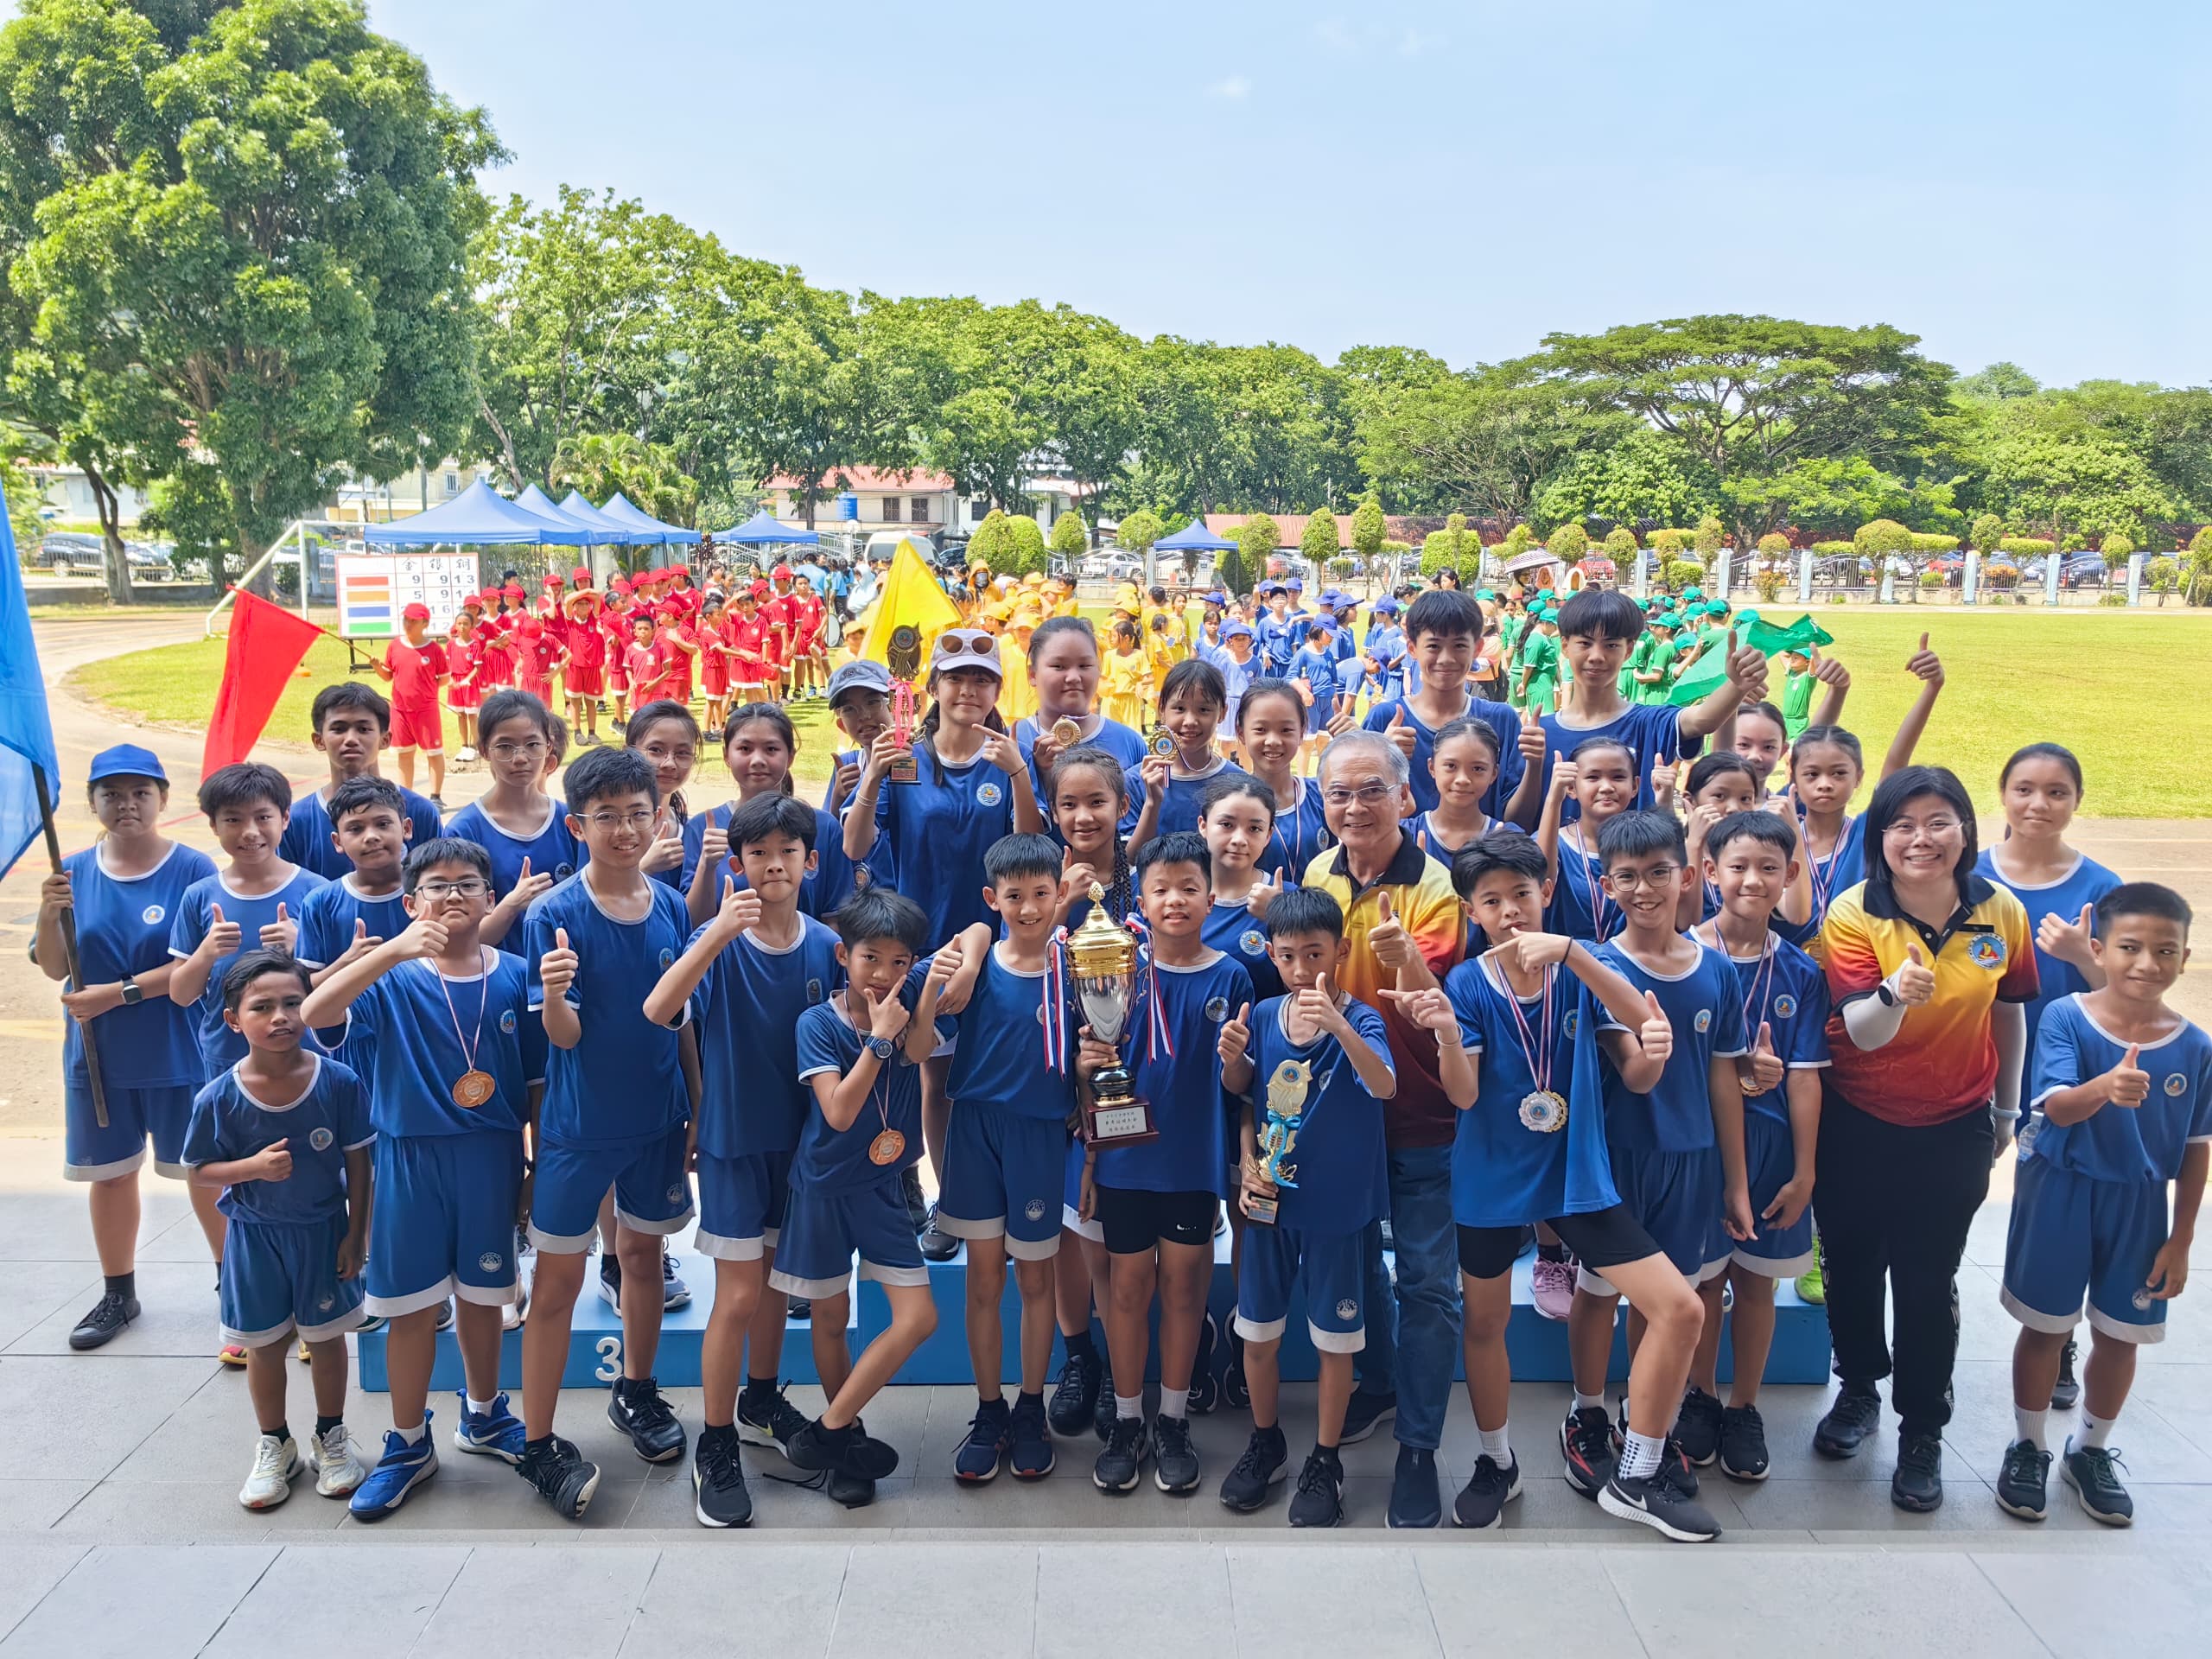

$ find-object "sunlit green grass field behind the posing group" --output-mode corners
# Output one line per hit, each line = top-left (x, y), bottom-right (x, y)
(71, 606), (2212, 818)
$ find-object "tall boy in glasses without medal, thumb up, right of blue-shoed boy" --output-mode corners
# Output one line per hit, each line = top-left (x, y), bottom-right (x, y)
(522, 750), (696, 1520)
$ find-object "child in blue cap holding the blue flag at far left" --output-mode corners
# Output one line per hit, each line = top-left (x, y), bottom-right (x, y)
(33, 743), (224, 1350)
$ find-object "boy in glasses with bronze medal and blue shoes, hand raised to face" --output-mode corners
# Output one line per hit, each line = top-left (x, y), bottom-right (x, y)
(303, 838), (546, 1522)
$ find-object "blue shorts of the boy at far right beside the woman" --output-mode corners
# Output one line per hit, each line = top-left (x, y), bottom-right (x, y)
(1999, 1157), (2168, 1343)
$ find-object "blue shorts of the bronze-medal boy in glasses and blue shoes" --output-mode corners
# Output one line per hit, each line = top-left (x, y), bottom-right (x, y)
(367, 1128), (522, 1319)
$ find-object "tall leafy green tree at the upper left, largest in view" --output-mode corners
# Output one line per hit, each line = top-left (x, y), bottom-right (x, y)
(0, 0), (500, 584)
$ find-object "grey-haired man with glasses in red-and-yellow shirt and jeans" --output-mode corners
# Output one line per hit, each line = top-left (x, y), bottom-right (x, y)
(1300, 732), (1466, 1526)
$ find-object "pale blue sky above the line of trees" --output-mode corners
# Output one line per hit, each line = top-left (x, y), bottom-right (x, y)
(26, 0), (2212, 385)
